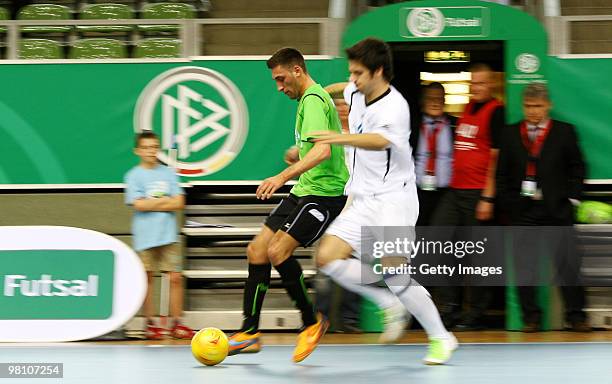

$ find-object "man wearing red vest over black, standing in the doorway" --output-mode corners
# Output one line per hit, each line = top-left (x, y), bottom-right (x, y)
(432, 64), (505, 330)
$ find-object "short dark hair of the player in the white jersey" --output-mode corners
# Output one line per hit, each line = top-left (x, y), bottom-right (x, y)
(346, 37), (393, 81)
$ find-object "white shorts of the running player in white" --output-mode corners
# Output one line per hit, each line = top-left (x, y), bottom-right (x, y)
(325, 191), (419, 258)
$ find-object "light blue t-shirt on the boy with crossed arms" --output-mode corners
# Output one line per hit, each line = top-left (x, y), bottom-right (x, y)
(125, 164), (183, 251)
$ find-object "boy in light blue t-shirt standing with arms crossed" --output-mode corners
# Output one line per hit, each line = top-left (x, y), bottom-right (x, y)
(125, 131), (193, 339)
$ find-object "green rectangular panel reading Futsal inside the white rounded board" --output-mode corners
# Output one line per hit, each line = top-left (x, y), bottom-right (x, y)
(0, 249), (115, 320)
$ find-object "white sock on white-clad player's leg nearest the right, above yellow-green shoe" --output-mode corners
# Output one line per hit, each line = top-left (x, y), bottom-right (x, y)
(385, 278), (449, 339)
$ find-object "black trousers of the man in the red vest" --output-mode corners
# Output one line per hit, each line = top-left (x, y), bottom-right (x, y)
(431, 188), (492, 323)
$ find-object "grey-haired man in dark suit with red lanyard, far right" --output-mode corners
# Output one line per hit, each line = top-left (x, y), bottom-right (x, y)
(496, 83), (590, 332)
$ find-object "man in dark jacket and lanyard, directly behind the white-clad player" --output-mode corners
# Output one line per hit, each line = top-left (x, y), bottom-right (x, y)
(410, 82), (457, 226)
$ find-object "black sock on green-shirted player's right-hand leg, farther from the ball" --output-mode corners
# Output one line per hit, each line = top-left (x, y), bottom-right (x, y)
(274, 257), (317, 327)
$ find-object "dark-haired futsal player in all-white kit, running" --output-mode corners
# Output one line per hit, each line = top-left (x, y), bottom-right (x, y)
(316, 38), (457, 365)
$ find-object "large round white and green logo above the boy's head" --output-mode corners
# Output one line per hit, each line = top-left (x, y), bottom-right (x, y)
(134, 66), (249, 177)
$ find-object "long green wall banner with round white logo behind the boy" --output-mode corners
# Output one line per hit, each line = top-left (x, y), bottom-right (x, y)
(0, 58), (346, 184)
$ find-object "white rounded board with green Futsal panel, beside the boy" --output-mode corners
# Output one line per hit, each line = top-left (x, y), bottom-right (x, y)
(0, 226), (146, 342)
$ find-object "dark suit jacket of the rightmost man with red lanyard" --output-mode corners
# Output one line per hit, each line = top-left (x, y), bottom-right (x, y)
(497, 120), (585, 225)
